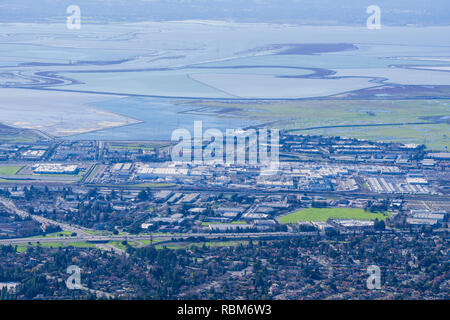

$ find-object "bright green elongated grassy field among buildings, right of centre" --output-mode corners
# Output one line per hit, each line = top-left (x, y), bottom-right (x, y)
(279, 208), (390, 224)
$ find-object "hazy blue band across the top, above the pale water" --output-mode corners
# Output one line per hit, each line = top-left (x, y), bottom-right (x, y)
(0, 0), (450, 25)
